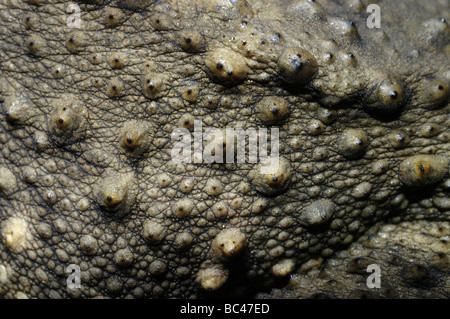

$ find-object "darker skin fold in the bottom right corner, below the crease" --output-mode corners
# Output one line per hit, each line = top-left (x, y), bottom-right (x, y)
(258, 220), (450, 299)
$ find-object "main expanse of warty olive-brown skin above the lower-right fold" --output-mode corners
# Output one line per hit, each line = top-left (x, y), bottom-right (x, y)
(0, 0), (450, 298)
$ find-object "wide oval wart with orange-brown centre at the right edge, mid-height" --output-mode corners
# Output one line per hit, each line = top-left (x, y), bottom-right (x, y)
(399, 155), (449, 187)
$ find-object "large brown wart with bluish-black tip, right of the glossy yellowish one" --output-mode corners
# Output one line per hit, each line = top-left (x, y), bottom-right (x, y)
(278, 48), (318, 84)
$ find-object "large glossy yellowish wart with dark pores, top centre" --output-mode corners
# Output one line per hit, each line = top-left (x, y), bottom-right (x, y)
(205, 48), (249, 86)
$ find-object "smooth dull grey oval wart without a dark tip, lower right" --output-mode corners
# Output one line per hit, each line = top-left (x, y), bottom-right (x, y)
(298, 199), (336, 226)
